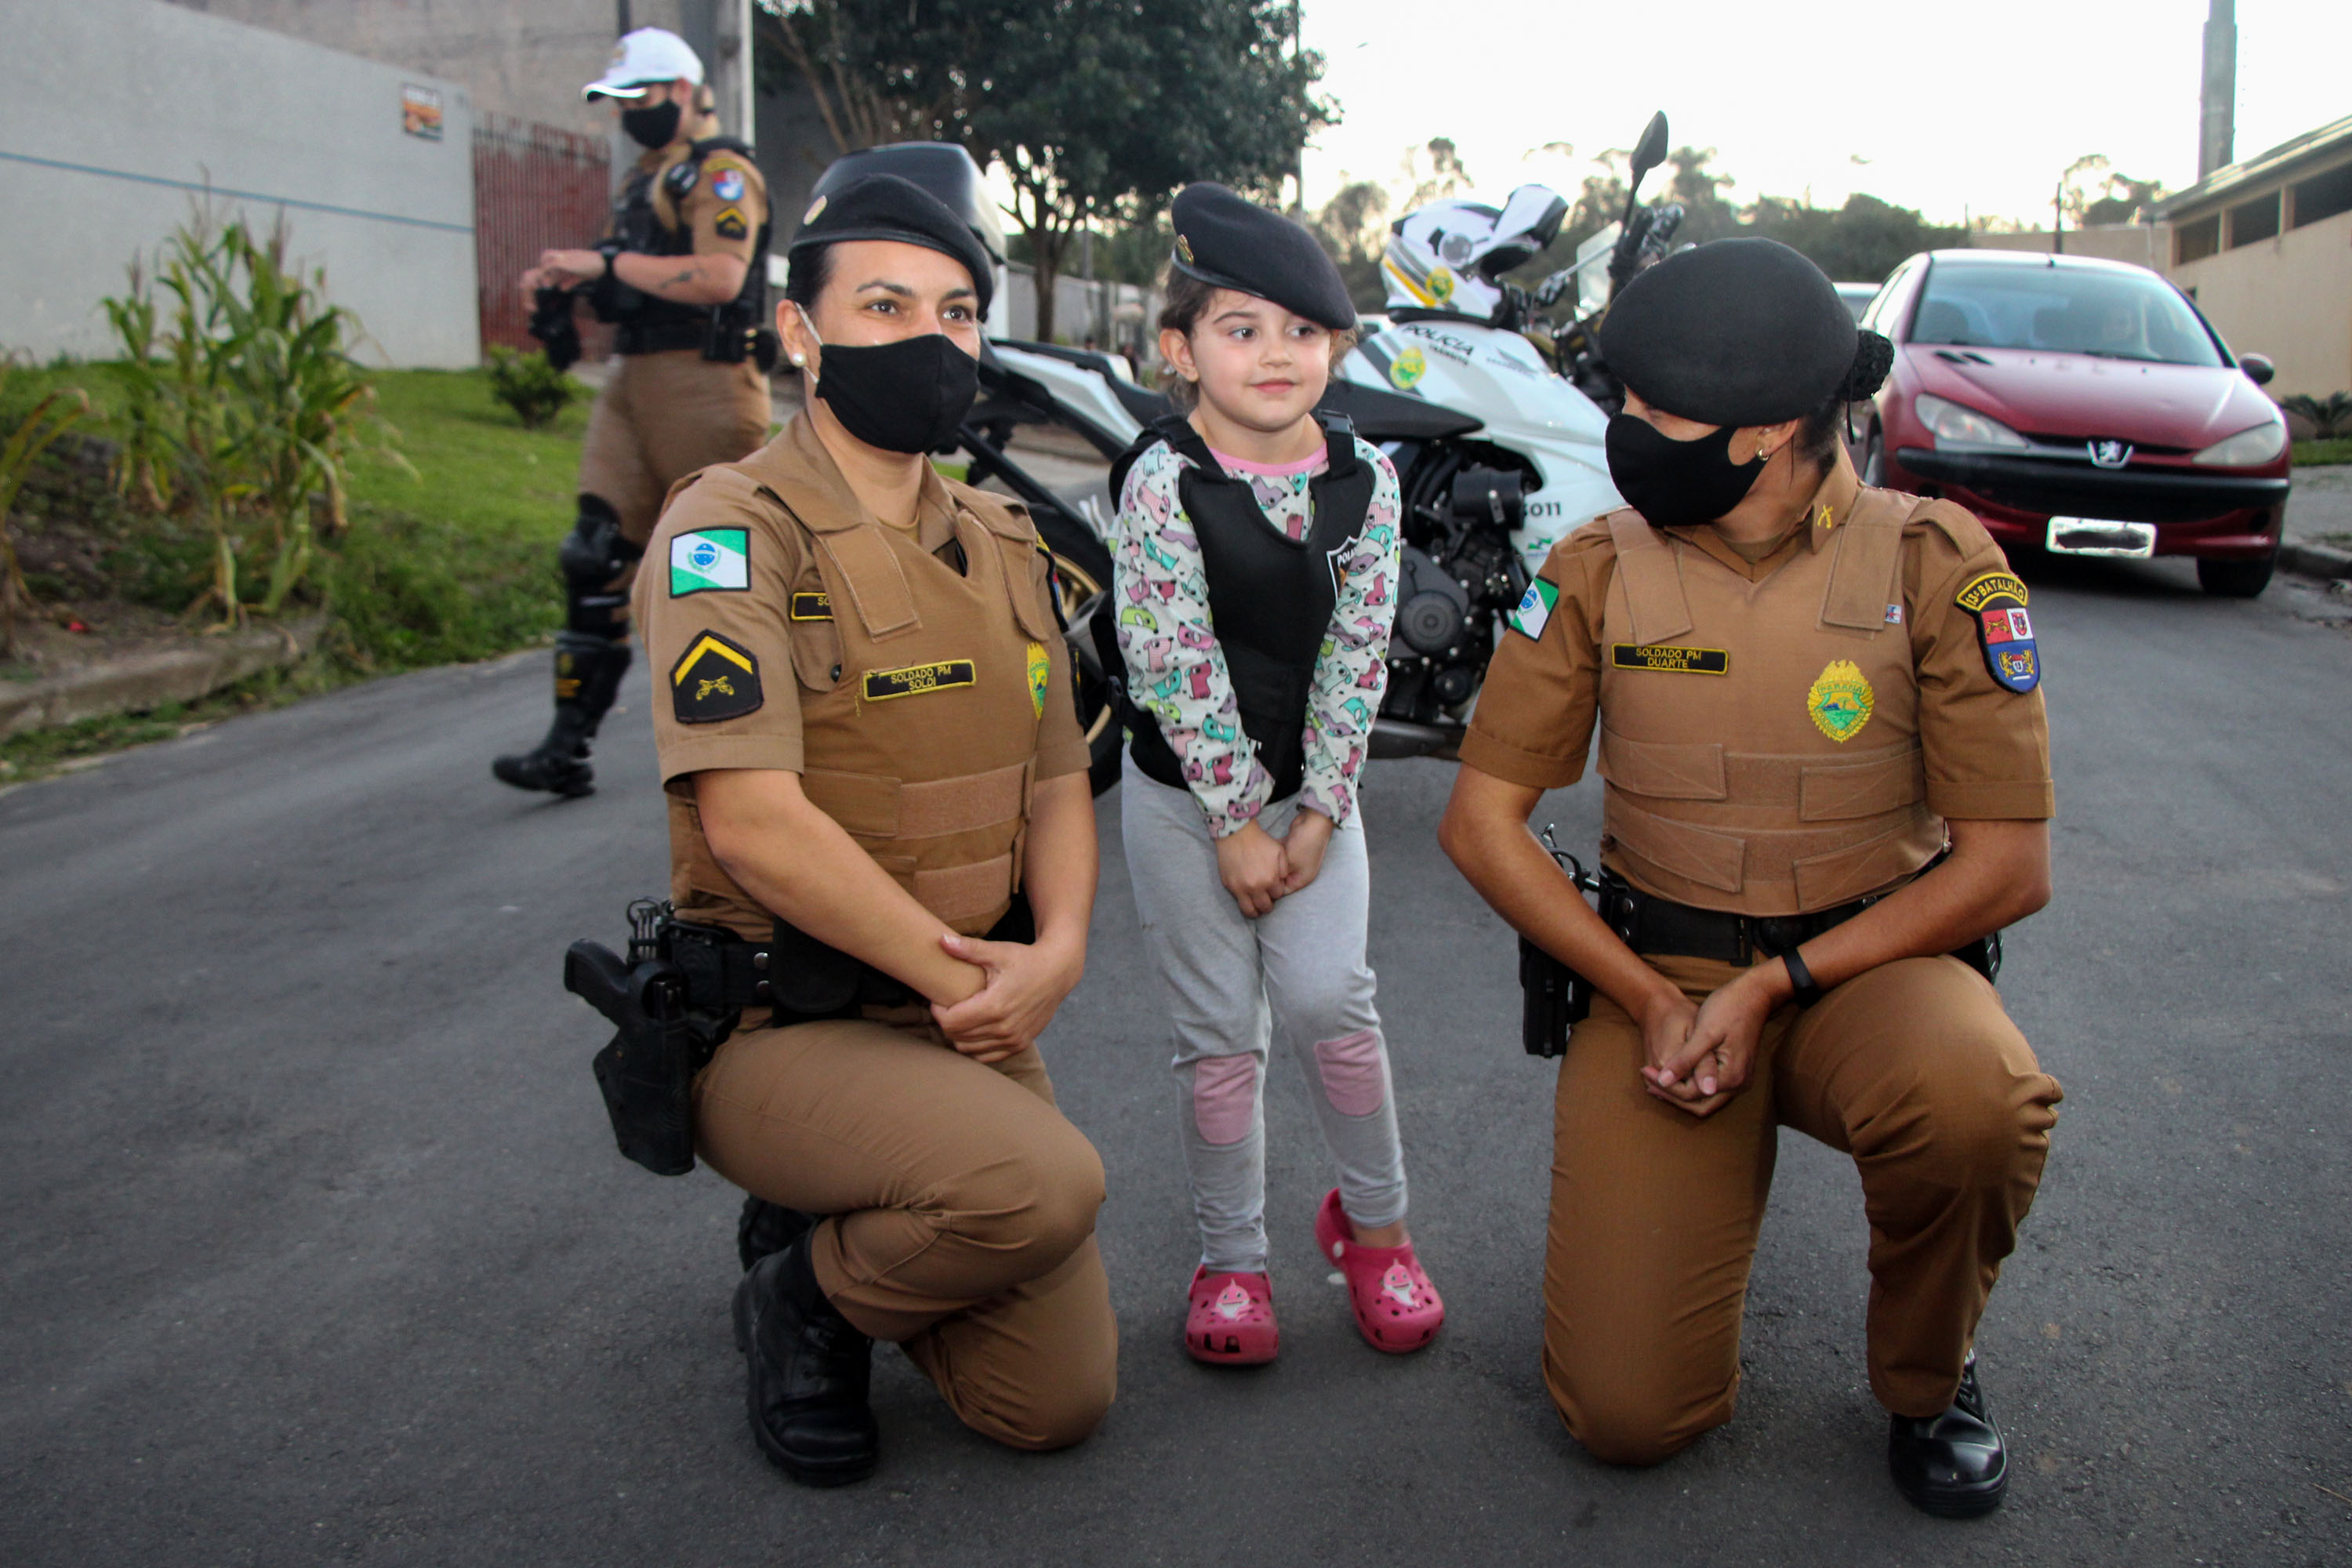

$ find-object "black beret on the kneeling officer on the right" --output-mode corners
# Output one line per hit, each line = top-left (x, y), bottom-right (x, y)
(1602, 240), (1884, 426)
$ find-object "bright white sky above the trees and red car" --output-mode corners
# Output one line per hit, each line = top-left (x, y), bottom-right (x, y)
(1303, 0), (2352, 226)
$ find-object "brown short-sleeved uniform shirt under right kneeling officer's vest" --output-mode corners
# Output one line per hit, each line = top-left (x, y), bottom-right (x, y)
(1461, 454), (2056, 846)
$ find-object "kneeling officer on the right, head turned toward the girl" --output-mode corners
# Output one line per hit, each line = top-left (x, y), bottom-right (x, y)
(1442, 240), (2058, 1516)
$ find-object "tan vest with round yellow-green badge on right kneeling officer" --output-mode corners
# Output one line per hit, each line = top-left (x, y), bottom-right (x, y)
(1599, 489), (1959, 914)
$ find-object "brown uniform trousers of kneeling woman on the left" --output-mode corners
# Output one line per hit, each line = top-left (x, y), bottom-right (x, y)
(694, 1020), (1120, 1448)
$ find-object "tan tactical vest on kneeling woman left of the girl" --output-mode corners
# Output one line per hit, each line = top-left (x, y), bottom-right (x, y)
(670, 430), (1061, 940)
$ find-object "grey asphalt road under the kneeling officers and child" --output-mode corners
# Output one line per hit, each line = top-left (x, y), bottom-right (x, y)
(0, 564), (2352, 1568)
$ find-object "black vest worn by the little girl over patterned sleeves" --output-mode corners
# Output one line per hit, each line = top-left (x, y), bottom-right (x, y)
(1096, 412), (1374, 799)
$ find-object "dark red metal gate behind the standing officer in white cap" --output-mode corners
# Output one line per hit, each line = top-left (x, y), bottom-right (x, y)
(473, 115), (612, 358)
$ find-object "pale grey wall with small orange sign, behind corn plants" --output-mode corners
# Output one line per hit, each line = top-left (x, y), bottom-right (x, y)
(0, 0), (480, 365)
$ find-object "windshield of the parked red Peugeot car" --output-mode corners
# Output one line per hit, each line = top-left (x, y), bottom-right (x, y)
(1910, 261), (2223, 365)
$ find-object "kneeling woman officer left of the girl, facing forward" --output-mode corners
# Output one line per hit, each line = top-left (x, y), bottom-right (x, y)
(637, 174), (1117, 1486)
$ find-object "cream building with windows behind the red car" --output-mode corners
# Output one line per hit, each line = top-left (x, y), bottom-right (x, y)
(2154, 115), (2352, 397)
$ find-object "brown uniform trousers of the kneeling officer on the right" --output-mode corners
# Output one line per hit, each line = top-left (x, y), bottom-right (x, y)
(1543, 956), (2060, 1465)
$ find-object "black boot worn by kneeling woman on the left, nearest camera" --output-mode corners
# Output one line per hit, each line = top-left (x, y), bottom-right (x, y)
(734, 1232), (882, 1486)
